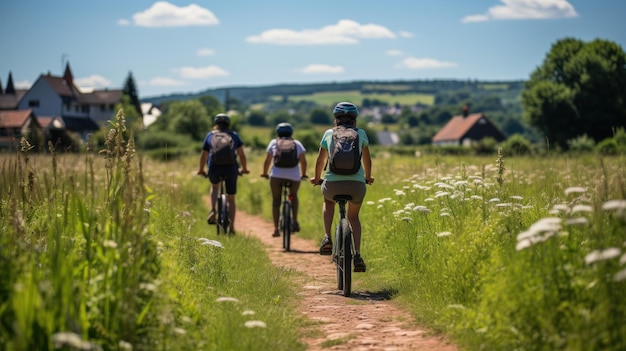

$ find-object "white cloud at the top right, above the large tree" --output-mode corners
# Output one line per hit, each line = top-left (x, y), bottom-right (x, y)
(461, 0), (578, 23)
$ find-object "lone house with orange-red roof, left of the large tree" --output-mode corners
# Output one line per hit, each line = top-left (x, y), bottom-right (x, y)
(432, 106), (506, 146)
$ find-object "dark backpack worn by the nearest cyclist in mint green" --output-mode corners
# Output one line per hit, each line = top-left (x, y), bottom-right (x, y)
(328, 125), (361, 175)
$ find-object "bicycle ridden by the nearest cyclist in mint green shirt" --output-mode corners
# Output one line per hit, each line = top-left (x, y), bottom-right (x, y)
(332, 195), (355, 297)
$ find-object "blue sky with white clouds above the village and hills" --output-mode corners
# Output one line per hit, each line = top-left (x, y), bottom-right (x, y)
(0, 0), (626, 97)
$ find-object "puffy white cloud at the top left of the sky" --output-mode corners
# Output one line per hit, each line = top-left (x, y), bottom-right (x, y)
(130, 1), (219, 27)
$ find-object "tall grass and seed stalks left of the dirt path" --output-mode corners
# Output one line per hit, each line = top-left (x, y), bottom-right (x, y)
(0, 112), (302, 350)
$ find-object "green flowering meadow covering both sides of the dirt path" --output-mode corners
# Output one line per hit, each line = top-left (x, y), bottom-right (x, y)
(0, 119), (626, 351)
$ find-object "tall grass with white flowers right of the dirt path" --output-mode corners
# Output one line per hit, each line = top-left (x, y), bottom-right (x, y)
(235, 152), (626, 350)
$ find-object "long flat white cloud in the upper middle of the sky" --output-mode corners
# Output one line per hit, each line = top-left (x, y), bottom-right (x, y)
(246, 19), (396, 45)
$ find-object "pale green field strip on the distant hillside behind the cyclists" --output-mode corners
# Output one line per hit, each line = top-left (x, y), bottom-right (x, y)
(274, 87), (435, 106)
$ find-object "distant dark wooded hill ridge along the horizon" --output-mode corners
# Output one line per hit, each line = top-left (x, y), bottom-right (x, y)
(141, 80), (524, 105)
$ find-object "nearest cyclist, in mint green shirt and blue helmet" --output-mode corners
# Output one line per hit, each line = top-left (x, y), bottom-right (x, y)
(310, 102), (374, 272)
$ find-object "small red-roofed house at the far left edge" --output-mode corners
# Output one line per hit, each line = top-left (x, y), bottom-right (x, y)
(0, 110), (43, 151)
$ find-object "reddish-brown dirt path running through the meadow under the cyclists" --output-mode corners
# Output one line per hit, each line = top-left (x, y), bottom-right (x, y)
(235, 211), (458, 351)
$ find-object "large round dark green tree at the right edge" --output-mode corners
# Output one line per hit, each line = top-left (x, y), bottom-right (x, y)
(522, 38), (626, 148)
